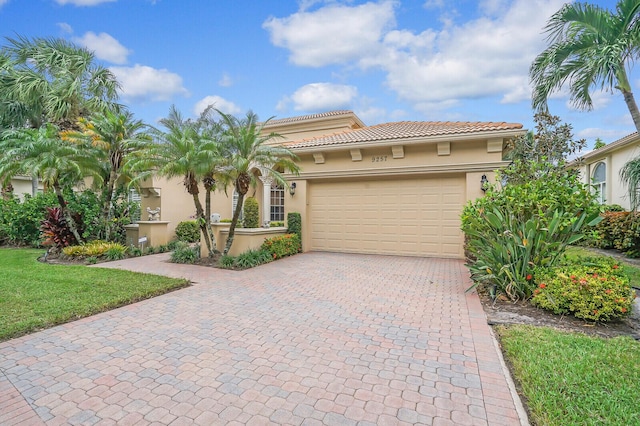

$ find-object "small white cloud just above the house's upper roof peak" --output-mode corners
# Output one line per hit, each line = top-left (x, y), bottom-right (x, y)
(290, 83), (358, 112)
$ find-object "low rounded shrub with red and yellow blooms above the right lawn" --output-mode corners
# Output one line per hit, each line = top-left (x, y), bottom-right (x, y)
(531, 264), (635, 322)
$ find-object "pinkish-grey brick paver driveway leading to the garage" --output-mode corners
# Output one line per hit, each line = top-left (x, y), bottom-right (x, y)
(0, 253), (524, 425)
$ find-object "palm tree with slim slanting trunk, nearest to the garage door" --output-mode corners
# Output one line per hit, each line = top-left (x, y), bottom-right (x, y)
(216, 110), (299, 255)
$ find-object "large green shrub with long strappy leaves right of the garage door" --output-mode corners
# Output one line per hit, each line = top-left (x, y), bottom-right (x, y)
(461, 163), (601, 301)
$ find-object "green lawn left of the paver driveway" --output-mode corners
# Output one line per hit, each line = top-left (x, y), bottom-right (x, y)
(0, 249), (187, 341)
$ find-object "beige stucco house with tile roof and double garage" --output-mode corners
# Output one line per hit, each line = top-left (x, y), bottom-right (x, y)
(141, 111), (525, 258)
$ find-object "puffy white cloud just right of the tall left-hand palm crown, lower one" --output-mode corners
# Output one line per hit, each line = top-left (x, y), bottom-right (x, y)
(110, 64), (189, 102)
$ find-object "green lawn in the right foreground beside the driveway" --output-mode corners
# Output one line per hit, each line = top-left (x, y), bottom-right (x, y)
(496, 326), (640, 426)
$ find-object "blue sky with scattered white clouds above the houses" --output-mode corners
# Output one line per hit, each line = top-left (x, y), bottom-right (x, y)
(0, 0), (640, 145)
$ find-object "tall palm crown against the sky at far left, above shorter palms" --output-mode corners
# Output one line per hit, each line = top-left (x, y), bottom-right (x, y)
(0, 37), (119, 195)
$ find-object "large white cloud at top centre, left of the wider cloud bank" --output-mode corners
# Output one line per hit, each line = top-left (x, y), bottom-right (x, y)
(263, 1), (395, 67)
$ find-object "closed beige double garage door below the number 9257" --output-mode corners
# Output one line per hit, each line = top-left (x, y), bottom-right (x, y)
(309, 176), (465, 258)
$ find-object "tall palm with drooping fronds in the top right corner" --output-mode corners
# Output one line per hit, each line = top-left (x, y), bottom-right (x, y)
(530, 0), (640, 132)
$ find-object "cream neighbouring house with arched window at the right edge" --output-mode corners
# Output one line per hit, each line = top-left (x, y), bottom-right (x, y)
(576, 133), (640, 210)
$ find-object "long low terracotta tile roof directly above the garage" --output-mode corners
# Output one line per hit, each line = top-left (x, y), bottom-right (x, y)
(285, 121), (522, 148)
